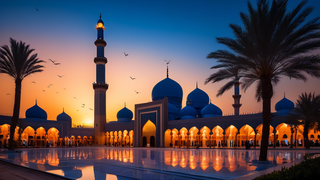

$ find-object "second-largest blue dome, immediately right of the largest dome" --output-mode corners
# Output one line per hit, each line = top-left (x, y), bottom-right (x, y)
(186, 85), (209, 109)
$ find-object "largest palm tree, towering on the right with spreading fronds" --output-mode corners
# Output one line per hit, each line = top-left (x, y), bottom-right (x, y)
(207, 0), (320, 161)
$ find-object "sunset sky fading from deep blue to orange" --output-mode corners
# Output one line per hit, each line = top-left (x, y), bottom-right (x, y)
(0, 0), (320, 125)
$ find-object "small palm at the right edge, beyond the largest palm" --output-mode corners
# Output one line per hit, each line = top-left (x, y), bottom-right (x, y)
(287, 93), (320, 149)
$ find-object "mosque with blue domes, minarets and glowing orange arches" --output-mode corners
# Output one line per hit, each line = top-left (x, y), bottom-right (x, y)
(0, 15), (320, 148)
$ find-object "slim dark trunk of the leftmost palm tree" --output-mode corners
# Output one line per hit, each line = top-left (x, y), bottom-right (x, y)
(9, 79), (22, 150)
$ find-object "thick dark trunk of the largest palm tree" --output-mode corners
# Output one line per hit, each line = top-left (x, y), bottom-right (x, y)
(259, 78), (273, 161)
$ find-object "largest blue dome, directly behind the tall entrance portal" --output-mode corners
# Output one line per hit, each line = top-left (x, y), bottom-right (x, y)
(152, 77), (183, 109)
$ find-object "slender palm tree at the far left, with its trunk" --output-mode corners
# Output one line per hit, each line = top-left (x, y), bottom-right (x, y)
(0, 38), (45, 150)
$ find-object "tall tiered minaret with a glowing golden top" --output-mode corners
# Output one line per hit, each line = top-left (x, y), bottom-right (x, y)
(93, 14), (108, 145)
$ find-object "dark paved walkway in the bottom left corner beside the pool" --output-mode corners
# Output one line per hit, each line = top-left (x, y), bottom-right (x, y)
(0, 160), (69, 180)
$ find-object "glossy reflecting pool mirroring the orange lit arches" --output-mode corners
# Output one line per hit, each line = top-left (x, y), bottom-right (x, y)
(0, 147), (312, 180)
